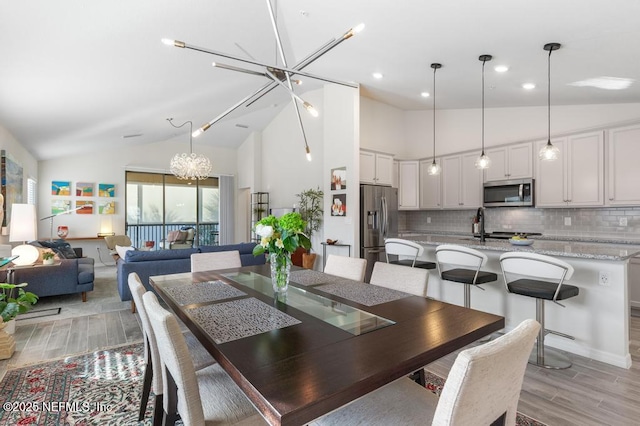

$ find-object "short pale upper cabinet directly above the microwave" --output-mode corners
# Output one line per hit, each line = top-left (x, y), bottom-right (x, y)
(484, 142), (533, 182)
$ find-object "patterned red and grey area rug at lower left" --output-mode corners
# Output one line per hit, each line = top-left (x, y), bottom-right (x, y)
(0, 343), (154, 426)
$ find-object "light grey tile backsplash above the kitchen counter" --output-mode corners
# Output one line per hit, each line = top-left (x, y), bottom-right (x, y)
(398, 207), (640, 240)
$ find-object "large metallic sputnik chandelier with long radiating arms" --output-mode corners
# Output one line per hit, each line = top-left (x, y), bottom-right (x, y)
(162, 0), (364, 161)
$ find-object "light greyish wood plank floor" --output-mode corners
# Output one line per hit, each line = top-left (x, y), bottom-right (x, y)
(0, 271), (640, 426)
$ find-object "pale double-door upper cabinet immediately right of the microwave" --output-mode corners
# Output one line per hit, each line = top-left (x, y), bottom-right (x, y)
(535, 132), (604, 207)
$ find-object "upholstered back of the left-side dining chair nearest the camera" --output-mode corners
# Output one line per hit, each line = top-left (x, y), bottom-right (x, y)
(142, 291), (205, 426)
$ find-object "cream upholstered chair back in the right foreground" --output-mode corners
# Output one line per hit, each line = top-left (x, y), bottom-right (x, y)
(432, 319), (540, 425)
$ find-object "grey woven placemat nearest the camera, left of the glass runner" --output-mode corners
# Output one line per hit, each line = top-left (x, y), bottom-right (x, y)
(187, 297), (301, 343)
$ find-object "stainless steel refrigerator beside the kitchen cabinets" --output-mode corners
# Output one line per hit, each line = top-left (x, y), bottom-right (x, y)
(360, 185), (398, 282)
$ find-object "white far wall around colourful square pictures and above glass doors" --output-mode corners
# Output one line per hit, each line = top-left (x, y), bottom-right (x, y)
(38, 138), (237, 243)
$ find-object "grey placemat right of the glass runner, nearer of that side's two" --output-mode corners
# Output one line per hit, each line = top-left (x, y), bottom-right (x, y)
(315, 279), (411, 306)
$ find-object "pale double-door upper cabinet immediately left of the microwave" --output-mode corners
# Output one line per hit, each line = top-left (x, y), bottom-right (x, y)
(442, 152), (482, 209)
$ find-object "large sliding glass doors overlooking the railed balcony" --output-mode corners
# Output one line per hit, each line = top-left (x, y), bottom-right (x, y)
(126, 172), (220, 248)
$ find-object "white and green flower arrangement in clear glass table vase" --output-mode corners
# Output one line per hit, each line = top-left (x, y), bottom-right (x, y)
(253, 212), (311, 292)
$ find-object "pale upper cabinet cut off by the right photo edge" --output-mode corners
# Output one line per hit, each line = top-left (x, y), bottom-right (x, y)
(606, 126), (640, 206)
